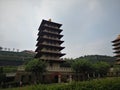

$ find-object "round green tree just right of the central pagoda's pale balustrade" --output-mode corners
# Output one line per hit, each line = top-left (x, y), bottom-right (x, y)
(72, 59), (93, 80)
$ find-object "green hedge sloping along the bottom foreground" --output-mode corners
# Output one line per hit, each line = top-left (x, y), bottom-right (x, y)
(4, 77), (120, 90)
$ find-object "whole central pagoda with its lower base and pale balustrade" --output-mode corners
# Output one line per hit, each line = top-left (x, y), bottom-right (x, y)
(35, 19), (72, 83)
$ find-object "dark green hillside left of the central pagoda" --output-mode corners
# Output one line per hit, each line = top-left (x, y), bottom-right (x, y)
(0, 51), (35, 66)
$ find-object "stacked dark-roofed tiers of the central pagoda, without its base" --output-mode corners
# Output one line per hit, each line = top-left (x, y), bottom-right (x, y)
(35, 20), (65, 62)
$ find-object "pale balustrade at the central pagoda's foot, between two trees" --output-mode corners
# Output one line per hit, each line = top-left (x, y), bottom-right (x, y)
(47, 66), (72, 72)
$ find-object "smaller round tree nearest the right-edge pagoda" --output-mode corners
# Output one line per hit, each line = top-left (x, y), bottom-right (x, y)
(94, 61), (110, 77)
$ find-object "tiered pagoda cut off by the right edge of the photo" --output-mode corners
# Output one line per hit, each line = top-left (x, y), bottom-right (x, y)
(112, 35), (120, 64)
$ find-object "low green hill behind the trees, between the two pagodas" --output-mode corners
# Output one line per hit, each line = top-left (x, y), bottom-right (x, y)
(60, 55), (115, 67)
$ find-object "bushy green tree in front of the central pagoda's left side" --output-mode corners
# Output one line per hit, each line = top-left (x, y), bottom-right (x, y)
(25, 59), (47, 83)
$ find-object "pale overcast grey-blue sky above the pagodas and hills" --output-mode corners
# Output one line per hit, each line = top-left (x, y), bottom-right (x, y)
(0, 0), (120, 58)
